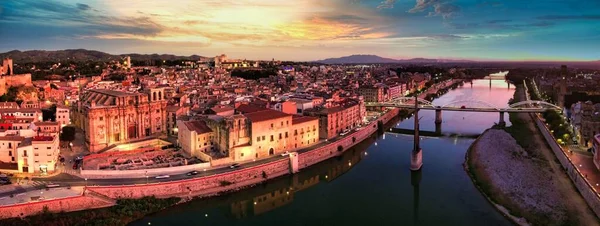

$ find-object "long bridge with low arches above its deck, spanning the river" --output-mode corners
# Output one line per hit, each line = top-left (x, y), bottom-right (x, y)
(365, 97), (561, 113)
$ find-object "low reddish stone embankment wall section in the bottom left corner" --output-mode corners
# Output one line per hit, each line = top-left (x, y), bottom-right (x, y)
(0, 194), (114, 219)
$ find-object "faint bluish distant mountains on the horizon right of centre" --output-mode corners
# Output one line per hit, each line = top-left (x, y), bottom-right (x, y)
(315, 55), (474, 64)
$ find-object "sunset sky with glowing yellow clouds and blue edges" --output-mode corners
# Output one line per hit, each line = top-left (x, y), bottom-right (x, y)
(0, 0), (600, 61)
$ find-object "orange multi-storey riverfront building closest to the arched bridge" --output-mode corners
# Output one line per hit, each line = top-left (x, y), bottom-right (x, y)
(304, 100), (364, 139)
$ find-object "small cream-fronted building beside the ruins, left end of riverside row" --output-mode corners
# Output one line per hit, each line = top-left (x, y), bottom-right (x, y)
(177, 120), (215, 159)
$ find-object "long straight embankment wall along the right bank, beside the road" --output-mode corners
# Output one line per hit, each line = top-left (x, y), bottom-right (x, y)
(530, 113), (600, 217)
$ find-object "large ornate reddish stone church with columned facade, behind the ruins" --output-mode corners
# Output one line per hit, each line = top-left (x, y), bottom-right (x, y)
(74, 88), (167, 152)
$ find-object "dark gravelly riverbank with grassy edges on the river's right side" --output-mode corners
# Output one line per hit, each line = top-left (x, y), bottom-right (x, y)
(465, 84), (600, 225)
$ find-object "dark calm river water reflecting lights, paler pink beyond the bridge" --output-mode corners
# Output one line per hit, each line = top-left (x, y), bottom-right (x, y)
(132, 80), (514, 226)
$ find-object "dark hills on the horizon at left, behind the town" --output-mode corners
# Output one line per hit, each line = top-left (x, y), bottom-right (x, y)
(0, 49), (207, 63)
